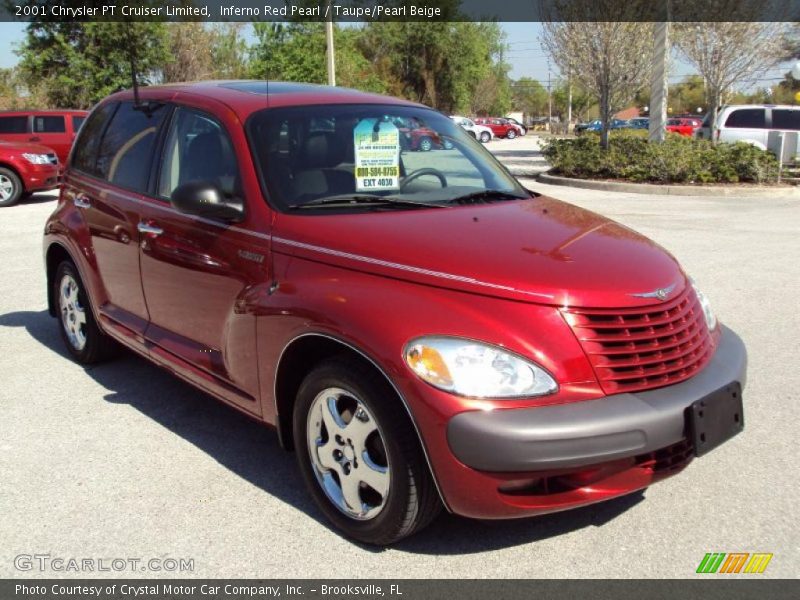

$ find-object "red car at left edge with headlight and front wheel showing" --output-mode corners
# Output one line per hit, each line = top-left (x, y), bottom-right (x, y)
(0, 141), (59, 206)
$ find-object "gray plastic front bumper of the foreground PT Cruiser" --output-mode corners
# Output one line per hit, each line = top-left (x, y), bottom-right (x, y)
(447, 327), (747, 472)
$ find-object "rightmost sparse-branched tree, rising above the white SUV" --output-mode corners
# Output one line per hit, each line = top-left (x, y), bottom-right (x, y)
(675, 21), (785, 135)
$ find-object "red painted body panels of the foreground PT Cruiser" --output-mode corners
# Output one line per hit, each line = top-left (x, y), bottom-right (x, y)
(44, 83), (744, 518)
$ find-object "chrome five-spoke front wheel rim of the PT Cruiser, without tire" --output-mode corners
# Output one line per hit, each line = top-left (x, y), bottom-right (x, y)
(306, 388), (391, 521)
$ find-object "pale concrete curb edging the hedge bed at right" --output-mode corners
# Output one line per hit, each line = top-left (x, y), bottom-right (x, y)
(536, 173), (800, 198)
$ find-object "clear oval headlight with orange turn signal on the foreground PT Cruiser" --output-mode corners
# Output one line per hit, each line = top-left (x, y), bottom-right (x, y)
(404, 337), (558, 398)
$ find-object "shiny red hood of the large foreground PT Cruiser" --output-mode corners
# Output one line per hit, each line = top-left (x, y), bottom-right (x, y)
(273, 196), (686, 308)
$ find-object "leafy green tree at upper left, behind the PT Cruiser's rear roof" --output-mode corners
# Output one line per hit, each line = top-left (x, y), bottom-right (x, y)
(17, 21), (169, 108)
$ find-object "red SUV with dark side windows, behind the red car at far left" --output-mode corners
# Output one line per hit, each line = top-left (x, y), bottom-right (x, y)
(0, 110), (89, 164)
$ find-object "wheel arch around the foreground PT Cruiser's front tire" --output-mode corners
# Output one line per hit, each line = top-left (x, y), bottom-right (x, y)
(273, 332), (450, 511)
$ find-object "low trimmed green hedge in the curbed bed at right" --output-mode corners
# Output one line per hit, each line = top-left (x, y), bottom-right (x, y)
(542, 130), (778, 184)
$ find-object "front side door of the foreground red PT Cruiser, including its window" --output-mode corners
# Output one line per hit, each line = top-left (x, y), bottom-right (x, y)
(140, 106), (262, 414)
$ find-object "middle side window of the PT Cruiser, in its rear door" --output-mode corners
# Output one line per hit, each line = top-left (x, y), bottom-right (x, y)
(96, 102), (167, 192)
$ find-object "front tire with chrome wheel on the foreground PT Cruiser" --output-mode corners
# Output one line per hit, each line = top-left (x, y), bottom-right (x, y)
(293, 357), (441, 545)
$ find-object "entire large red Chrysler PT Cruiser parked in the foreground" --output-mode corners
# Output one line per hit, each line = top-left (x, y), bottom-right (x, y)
(44, 82), (746, 544)
